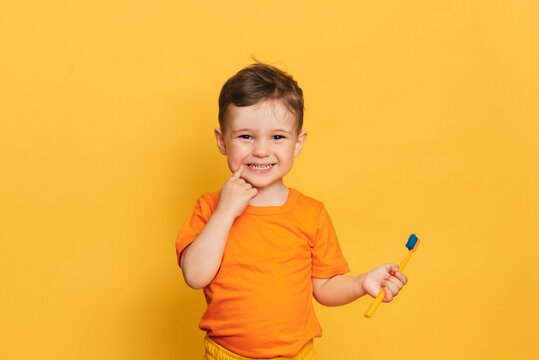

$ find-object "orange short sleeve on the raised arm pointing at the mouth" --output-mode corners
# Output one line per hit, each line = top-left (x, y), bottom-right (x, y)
(176, 195), (215, 265)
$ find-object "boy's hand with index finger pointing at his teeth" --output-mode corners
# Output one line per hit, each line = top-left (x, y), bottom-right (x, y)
(215, 165), (258, 219)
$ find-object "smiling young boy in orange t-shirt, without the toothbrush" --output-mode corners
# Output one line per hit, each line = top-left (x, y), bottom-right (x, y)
(176, 63), (407, 359)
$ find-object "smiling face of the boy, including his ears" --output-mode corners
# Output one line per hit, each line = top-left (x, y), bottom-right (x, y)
(215, 101), (307, 190)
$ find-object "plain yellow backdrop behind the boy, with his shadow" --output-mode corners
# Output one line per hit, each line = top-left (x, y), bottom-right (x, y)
(0, 0), (539, 359)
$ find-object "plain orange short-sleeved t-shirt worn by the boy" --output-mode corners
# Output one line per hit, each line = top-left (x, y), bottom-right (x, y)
(176, 189), (350, 358)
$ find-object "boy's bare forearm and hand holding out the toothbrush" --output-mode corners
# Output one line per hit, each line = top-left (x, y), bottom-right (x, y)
(312, 264), (408, 306)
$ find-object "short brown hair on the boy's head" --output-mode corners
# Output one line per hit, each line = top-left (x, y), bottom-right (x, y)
(219, 62), (304, 134)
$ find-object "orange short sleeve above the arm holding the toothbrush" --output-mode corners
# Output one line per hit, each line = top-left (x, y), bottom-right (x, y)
(311, 205), (350, 278)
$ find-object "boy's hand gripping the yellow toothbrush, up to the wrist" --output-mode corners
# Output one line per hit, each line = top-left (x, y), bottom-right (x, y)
(361, 264), (408, 302)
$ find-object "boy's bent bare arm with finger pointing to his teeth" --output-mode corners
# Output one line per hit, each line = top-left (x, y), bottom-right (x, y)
(180, 166), (257, 289)
